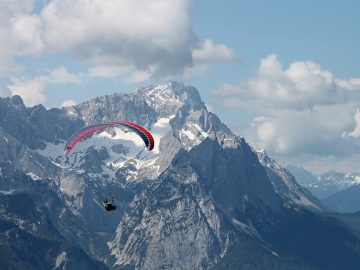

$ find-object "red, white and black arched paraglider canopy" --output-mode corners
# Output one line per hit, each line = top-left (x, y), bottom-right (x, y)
(65, 120), (154, 155)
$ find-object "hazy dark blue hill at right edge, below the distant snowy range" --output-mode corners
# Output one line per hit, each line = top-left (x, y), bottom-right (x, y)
(323, 185), (360, 213)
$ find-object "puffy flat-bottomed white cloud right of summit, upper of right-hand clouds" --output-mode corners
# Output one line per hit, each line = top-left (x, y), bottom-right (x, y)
(213, 54), (360, 110)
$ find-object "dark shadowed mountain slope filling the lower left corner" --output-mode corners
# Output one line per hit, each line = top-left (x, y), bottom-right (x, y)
(0, 162), (107, 270)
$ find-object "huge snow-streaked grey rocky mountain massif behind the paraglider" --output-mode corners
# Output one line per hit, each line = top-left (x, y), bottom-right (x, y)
(0, 82), (360, 269)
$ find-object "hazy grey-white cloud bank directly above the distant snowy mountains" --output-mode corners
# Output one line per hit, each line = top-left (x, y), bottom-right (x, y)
(244, 104), (360, 173)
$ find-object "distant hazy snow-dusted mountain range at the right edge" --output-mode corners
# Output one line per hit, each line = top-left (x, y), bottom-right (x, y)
(287, 166), (360, 200)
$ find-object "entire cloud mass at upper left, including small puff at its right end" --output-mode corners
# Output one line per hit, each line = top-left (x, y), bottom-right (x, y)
(0, 0), (234, 81)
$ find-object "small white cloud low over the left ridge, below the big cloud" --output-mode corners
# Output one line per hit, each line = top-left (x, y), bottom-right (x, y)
(8, 67), (82, 106)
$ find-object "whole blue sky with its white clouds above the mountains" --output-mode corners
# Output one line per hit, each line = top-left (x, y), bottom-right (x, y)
(0, 0), (360, 173)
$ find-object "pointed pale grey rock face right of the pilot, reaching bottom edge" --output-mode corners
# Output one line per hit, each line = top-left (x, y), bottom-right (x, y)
(112, 152), (228, 269)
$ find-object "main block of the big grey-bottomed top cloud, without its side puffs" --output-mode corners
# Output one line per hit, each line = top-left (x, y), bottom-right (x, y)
(41, 0), (196, 75)
